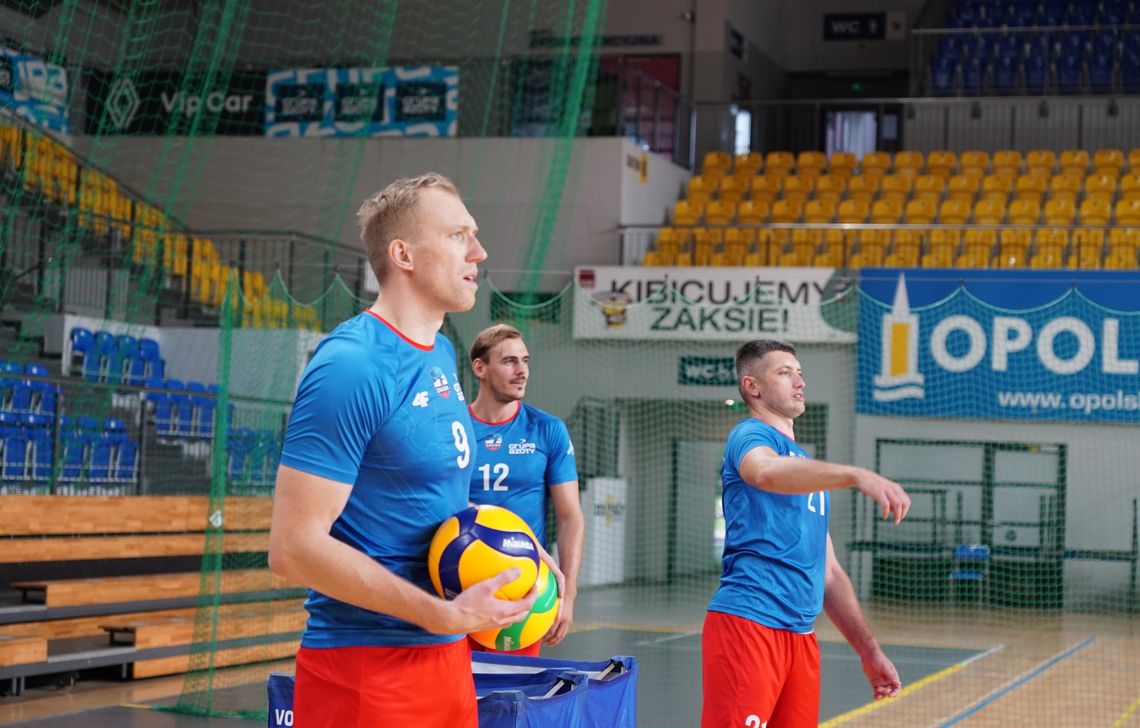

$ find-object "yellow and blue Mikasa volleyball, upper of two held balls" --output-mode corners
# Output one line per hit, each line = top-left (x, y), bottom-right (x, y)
(428, 505), (545, 599)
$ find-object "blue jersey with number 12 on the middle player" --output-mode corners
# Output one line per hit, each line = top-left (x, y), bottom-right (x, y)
(471, 402), (578, 548)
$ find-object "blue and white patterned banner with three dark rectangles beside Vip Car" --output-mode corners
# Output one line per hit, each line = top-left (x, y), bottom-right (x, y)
(266, 66), (459, 137)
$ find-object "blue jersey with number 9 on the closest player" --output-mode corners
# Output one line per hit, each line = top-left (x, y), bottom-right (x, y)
(280, 311), (474, 647)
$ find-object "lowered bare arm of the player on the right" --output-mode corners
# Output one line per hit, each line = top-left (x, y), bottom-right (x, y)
(823, 533), (903, 701)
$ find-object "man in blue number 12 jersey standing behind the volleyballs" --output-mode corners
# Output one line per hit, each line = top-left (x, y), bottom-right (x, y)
(470, 324), (585, 655)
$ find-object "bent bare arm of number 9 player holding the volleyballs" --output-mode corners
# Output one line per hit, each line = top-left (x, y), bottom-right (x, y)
(269, 465), (536, 635)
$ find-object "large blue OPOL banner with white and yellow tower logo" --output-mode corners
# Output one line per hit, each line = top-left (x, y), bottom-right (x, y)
(856, 269), (1140, 423)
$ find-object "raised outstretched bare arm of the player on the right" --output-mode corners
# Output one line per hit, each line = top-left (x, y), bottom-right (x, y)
(740, 445), (911, 523)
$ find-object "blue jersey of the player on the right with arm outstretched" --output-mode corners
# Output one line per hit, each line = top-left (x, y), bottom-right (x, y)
(709, 418), (831, 633)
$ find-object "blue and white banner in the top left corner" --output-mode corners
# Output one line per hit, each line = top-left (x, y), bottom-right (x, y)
(0, 46), (71, 134)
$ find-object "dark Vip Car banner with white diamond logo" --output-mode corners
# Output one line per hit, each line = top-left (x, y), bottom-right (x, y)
(86, 71), (266, 136)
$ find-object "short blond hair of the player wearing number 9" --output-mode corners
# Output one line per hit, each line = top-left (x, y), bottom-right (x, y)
(357, 172), (459, 283)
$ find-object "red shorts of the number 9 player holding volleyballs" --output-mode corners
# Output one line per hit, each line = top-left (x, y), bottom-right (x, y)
(293, 639), (479, 728)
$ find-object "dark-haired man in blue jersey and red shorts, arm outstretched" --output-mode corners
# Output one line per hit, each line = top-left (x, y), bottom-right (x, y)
(701, 340), (911, 728)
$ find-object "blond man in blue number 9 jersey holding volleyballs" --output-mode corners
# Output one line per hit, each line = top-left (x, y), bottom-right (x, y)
(269, 174), (544, 728)
